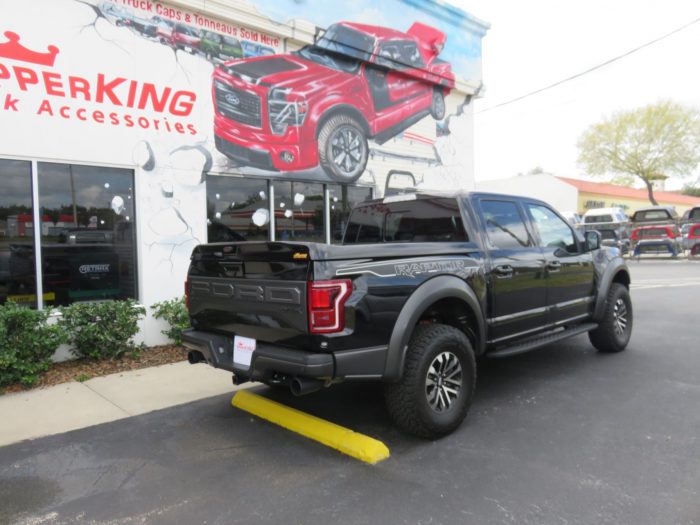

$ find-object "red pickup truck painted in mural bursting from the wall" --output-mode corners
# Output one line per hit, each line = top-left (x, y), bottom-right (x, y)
(212, 22), (454, 183)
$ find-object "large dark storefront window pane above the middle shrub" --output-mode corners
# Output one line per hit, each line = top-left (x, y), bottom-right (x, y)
(38, 162), (136, 306)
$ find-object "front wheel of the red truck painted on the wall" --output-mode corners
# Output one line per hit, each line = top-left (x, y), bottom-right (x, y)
(318, 115), (369, 183)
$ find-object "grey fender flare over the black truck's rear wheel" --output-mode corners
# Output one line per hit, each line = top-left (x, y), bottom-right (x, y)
(384, 275), (486, 381)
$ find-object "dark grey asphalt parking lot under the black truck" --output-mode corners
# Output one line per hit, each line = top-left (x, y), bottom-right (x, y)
(0, 260), (700, 525)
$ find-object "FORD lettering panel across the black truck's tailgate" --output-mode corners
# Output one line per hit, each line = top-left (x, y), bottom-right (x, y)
(190, 279), (303, 305)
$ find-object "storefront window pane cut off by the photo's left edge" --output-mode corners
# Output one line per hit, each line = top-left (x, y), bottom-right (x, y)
(0, 159), (36, 306)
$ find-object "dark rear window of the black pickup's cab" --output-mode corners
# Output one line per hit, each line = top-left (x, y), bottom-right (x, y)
(343, 198), (469, 244)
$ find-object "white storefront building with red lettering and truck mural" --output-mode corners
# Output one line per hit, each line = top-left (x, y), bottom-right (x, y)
(0, 0), (488, 344)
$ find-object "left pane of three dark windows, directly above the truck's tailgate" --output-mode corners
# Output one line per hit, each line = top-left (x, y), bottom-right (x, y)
(207, 175), (270, 242)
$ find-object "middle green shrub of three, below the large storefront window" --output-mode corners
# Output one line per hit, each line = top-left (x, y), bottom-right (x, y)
(59, 299), (146, 359)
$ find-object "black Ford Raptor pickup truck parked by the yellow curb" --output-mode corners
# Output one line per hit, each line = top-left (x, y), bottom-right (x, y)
(183, 193), (632, 438)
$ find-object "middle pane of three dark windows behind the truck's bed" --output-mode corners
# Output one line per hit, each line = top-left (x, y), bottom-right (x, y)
(274, 181), (326, 242)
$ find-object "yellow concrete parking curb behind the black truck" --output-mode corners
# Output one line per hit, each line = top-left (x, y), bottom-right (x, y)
(231, 390), (389, 465)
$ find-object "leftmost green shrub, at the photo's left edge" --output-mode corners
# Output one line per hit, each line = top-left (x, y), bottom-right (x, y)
(0, 301), (67, 386)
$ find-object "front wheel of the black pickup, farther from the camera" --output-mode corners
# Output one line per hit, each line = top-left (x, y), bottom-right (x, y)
(588, 283), (633, 353)
